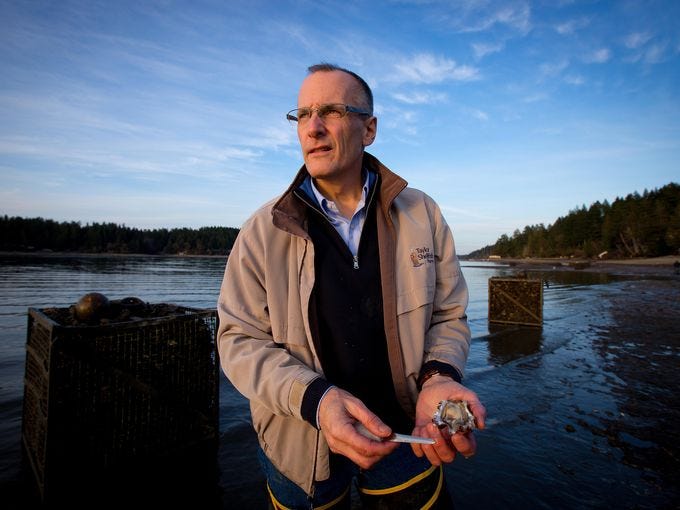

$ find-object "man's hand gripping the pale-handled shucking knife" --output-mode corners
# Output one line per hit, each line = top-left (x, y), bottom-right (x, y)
(319, 387), (399, 469)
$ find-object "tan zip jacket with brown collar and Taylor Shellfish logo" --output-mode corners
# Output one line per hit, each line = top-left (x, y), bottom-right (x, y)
(217, 154), (470, 494)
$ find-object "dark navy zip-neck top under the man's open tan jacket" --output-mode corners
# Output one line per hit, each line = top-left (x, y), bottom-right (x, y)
(308, 191), (413, 432)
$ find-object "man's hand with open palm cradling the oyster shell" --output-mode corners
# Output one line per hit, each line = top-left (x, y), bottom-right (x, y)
(411, 375), (486, 466)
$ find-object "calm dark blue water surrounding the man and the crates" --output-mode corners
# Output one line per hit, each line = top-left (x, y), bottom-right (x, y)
(0, 253), (680, 510)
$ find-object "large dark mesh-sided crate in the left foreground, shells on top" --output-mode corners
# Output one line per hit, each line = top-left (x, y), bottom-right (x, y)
(22, 306), (219, 502)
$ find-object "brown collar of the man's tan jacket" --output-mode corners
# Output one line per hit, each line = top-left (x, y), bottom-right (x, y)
(272, 152), (408, 238)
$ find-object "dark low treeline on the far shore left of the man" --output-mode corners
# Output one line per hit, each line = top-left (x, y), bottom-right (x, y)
(0, 216), (238, 255)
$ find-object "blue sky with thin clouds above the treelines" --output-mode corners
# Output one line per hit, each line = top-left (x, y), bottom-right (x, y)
(0, 0), (680, 254)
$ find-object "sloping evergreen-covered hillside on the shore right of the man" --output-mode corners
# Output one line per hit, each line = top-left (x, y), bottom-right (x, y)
(467, 183), (680, 258)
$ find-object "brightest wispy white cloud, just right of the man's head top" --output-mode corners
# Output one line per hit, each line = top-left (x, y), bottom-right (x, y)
(393, 53), (480, 84)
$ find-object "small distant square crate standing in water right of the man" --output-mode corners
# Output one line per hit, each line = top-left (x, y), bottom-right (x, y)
(489, 277), (543, 326)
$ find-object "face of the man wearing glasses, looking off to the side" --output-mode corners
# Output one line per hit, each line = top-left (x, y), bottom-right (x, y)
(298, 71), (377, 180)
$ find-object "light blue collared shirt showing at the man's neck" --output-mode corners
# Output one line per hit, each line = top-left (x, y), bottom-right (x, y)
(302, 171), (376, 258)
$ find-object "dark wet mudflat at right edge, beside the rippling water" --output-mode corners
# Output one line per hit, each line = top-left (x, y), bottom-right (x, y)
(591, 279), (680, 494)
